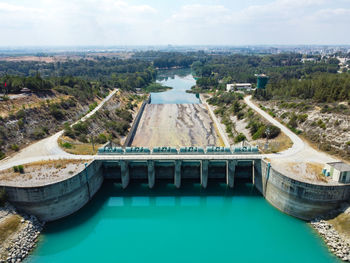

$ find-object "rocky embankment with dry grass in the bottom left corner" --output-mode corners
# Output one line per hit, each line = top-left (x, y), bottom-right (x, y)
(0, 204), (44, 263)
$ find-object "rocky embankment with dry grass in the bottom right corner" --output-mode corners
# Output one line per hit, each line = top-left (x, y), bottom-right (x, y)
(310, 208), (350, 262)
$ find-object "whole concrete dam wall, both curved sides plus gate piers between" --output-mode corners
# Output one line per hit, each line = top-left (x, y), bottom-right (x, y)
(4, 160), (350, 221)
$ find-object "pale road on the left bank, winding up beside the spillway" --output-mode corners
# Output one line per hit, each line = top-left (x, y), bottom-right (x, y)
(0, 89), (118, 170)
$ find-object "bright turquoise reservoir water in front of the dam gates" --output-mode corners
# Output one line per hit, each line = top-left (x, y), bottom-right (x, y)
(27, 182), (338, 263)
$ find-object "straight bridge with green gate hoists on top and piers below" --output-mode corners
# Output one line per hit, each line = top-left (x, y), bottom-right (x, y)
(95, 147), (262, 188)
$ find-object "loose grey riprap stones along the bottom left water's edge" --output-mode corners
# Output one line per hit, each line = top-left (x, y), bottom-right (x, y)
(0, 205), (44, 263)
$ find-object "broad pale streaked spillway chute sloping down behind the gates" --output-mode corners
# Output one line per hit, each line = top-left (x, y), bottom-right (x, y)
(132, 104), (220, 147)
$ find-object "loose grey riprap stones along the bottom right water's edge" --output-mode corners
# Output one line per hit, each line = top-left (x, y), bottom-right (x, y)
(310, 219), (350, 262)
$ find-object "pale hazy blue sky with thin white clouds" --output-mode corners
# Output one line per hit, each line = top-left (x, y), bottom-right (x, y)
(0, 0), (350, 46)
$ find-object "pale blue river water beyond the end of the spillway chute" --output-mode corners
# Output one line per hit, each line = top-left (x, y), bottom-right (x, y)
(151, 69), (200, 104)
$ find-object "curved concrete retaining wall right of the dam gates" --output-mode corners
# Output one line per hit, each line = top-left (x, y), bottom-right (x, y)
(254, 160), (350, 220)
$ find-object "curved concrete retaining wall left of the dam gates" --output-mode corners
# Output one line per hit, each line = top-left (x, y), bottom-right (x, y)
(4, 162), (104, 221)
